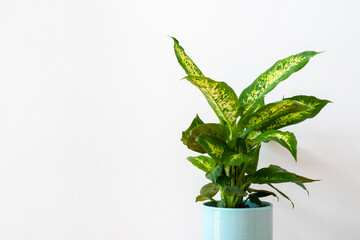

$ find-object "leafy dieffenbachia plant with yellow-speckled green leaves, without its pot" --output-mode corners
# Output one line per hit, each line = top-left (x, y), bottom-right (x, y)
(173, 38), (330, 208)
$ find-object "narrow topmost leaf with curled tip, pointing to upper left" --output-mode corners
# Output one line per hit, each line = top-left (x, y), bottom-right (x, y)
(171, 37), (204, 76)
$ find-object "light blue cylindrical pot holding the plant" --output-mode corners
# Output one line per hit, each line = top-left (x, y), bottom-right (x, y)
(202, 202), (273, 240)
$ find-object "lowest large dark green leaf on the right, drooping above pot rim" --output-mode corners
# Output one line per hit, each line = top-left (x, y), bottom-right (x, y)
(251, 165), (307, 191)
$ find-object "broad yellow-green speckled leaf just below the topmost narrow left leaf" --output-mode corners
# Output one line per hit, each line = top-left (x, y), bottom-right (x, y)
(185, 76), (240, 129)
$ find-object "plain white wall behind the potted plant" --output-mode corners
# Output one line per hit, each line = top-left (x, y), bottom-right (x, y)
(0, 0), (360, 240)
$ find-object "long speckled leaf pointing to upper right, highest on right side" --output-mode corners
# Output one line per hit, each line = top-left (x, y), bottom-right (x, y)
(239, 51), (319, 106)
